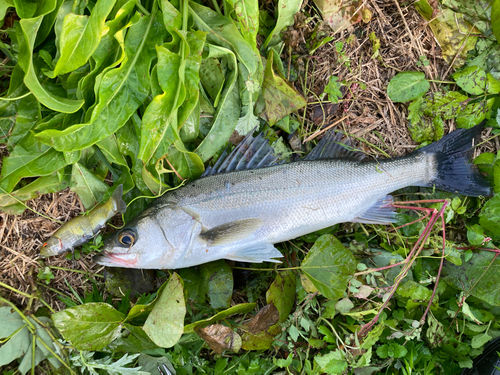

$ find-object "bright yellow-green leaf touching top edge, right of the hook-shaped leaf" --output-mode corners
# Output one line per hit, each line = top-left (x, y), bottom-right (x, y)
(47, 0), (116, 78)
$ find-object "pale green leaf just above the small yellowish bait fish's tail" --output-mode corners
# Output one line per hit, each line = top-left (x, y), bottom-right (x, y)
(70, 163), (109, 210)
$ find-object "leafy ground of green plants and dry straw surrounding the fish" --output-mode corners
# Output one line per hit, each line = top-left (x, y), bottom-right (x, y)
(0, 0), (500, 374)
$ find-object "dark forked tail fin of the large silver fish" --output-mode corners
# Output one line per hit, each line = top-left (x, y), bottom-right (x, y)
(417, 121), (493, 197)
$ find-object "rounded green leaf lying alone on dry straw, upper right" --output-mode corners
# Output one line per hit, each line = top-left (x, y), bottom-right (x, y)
(387, 72), (430, 103)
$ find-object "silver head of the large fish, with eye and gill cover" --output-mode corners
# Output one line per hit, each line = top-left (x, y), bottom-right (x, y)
(94, 209), (193, 269)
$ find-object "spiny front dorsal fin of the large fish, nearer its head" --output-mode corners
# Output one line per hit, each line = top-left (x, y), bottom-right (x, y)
(202, 131), (281, 177)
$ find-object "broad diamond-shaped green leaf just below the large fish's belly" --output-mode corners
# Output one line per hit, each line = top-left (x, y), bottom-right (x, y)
(300, 234), (357, 300)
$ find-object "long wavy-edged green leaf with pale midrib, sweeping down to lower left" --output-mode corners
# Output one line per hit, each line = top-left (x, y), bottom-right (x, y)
(36, 8), (164, 151)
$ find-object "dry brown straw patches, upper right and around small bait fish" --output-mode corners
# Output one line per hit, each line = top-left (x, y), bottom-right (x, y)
(0, 0), (500, 310)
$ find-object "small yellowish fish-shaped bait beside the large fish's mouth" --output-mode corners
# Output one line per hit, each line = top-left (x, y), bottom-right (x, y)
(40, 185), (127, 257)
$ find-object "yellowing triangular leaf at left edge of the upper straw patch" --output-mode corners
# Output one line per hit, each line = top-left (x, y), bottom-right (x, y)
(261, 53), (307, 126)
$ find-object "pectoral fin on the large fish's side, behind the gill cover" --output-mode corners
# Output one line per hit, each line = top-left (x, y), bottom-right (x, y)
(200, 218), (262, 246)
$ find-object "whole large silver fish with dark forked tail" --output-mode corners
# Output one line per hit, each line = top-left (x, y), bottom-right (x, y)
(95, 125), (492, 269)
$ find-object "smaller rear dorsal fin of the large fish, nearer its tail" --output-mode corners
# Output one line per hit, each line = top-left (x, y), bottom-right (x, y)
(304, 131), (365, 160)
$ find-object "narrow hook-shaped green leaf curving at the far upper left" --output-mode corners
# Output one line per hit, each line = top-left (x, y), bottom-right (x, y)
(19, 16), (83, 113)
